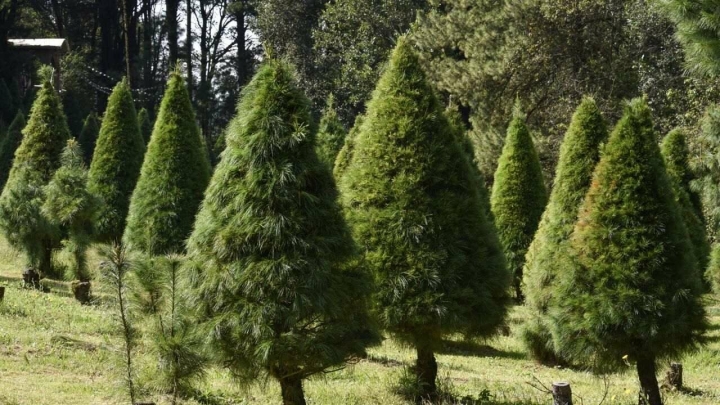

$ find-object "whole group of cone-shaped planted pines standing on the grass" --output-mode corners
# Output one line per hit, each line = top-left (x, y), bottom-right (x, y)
(0, 35), (708, 405)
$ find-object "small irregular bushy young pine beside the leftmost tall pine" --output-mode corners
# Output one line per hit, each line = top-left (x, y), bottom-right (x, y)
(42, 139), (100, 281)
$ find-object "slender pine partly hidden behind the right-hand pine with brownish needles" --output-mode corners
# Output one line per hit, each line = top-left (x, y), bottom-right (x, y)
(523, 97), (608, 363)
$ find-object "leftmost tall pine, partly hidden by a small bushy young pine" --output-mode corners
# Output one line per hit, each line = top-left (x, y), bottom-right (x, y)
(0, 82), (70, 276)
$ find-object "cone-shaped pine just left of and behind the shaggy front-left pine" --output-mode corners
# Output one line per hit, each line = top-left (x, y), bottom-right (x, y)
(125, 73), (210, 252)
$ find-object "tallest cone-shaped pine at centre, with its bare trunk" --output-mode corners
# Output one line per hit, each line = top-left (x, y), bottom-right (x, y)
(336, 39), (509, 399)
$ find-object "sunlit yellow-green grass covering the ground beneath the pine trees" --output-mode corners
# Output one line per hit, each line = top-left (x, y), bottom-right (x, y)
(0, 235), (720, 405)
